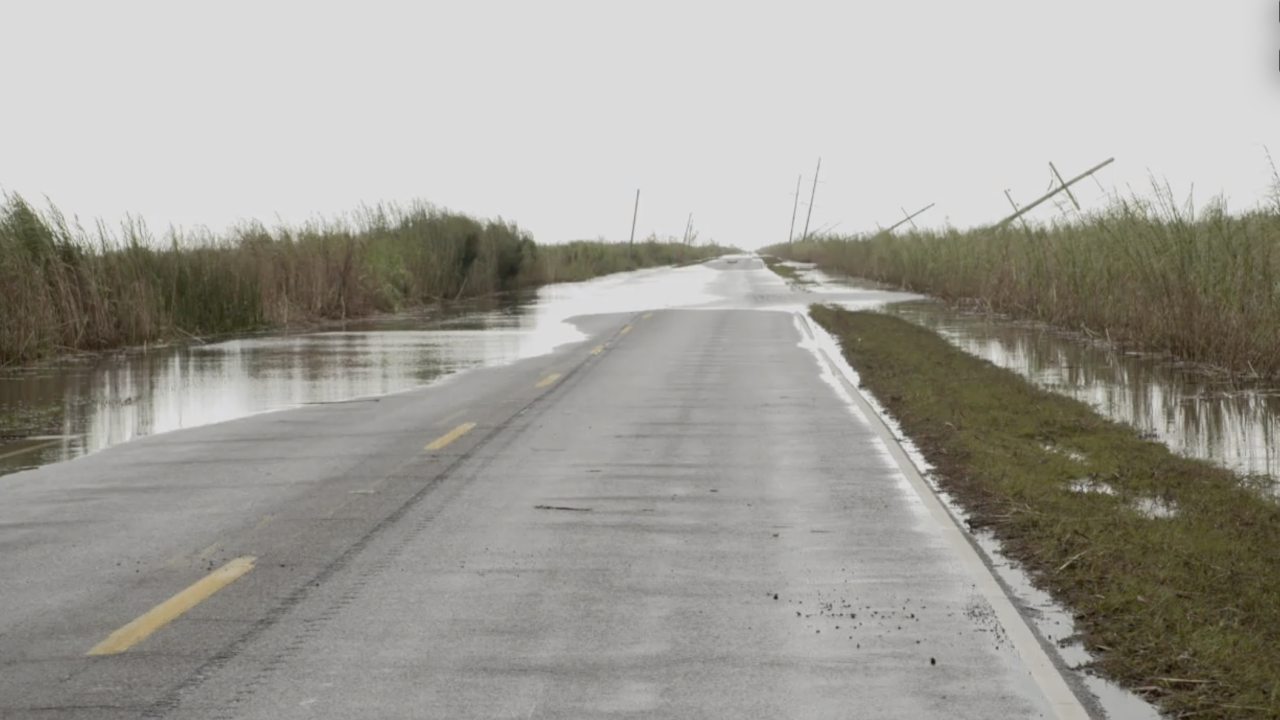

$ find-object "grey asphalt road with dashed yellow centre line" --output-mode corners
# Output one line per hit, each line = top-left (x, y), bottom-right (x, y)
(0, 259), (1080, 720)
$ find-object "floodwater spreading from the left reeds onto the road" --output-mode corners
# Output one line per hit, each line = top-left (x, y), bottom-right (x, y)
(0, 260), (722, 475)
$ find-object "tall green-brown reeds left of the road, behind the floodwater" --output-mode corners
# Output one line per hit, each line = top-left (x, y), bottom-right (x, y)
(0, 196), (727, 365)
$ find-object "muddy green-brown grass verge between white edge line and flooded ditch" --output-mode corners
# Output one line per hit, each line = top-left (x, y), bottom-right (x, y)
(808, 303), (1280, 719)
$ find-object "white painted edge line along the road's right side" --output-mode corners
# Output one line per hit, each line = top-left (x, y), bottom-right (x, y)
(796, 313), (1089, 720)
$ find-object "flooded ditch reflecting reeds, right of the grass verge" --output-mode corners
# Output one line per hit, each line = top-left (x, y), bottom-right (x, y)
(886, 301), (1280, 478)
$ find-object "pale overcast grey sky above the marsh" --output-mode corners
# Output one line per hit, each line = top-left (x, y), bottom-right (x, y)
(0, 0), (1280, 247)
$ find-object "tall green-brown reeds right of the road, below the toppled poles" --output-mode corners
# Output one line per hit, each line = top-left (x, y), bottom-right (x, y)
(765, 178), (1280, 378)
